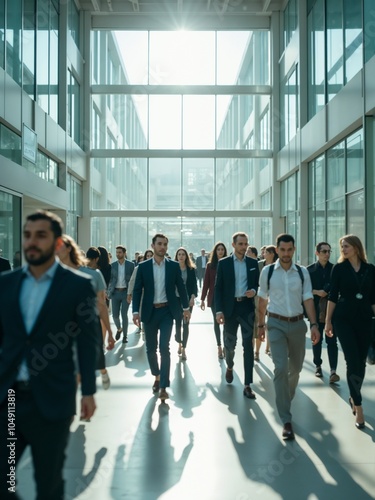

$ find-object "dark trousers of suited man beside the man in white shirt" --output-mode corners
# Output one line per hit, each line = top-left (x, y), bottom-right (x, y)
(224, 300), (254, 385)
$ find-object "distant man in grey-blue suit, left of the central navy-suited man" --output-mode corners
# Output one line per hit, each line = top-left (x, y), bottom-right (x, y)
(107, 245), (134, 344)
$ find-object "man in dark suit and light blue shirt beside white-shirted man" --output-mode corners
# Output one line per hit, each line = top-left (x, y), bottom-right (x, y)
(214, 233), (259, 399)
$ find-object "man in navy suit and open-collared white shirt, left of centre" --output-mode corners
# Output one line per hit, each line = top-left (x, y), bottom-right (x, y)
(133, 234), (190, 401)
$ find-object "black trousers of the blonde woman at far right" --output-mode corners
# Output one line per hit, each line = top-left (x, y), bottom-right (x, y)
(333, 318), (372, 406)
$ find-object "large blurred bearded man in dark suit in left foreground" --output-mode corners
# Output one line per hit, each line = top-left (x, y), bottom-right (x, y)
(0, 211), (100, 500)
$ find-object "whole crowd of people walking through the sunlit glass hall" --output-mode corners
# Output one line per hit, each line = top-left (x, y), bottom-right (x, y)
(0, 211), (375, 499)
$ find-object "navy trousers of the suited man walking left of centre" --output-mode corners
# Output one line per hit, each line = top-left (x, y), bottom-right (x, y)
(144, 306), (173, 388)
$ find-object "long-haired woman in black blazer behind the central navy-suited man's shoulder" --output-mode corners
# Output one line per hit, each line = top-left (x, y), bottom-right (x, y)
(174, 247), (198, 359)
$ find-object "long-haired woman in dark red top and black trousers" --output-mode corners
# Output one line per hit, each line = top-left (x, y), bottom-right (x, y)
(201, 241), (227, 359)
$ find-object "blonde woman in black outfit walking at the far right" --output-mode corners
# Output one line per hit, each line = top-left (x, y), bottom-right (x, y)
(325, 234), (375, 429)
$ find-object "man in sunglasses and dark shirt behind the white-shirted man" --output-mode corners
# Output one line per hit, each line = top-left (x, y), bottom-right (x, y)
(307, 241), (340, 384)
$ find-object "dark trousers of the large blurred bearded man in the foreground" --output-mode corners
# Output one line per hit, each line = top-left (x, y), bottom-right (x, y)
(0, 391), (72, 500)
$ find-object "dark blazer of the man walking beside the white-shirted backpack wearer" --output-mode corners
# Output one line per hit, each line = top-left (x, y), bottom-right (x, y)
(214, 255), (259, 317)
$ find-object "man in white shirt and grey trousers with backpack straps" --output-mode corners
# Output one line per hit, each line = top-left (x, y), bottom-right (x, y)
(258, 233), (320, 440)
